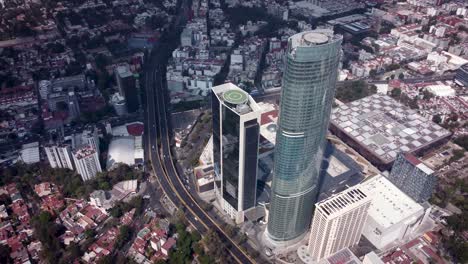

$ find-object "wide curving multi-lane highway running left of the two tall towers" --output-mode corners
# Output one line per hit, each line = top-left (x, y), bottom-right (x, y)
(143, 1), (255, 264)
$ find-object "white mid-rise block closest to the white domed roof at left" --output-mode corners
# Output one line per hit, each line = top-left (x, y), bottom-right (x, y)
(73, 145), (102, 181)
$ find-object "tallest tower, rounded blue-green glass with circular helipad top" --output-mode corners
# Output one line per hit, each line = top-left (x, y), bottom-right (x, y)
(267, 30), (342, 242)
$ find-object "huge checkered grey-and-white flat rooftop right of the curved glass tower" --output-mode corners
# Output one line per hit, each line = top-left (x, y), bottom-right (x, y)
(331, 94), (450, 163)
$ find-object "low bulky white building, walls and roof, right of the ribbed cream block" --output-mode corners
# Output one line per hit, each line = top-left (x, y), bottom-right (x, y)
(359, 175), (425, 250)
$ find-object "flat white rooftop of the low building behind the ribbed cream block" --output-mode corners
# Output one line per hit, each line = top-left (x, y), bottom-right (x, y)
(359, 175), (424, 228)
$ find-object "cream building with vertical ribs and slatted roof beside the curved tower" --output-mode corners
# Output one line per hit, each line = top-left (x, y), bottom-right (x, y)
(298, 187), (371, 263)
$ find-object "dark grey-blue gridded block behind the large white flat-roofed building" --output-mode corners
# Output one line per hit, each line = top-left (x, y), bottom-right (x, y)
(388, 153), (437, 203)
